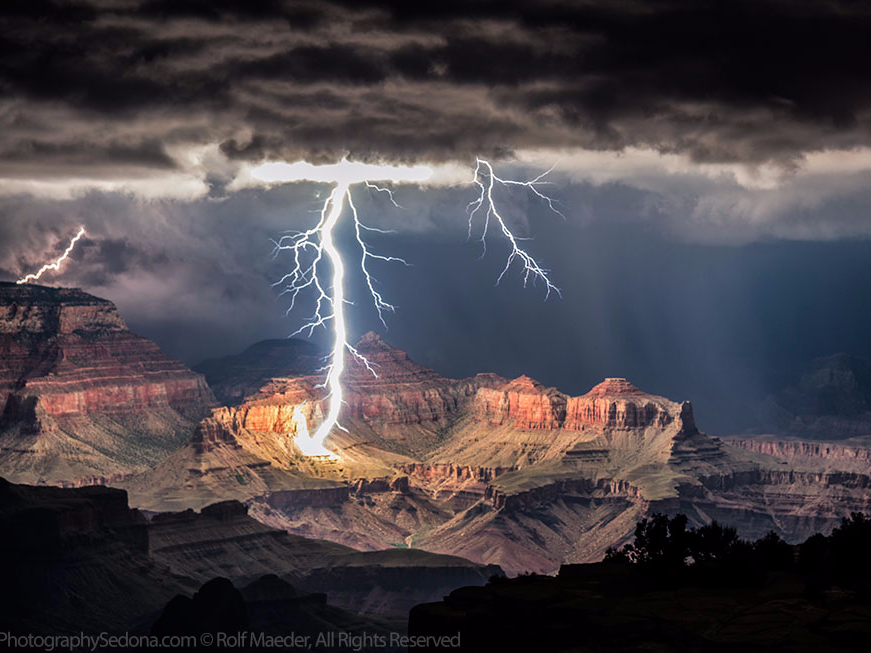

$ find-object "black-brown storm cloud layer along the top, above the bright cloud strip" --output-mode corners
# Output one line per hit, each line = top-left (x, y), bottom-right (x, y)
(0, 0), (871, 174)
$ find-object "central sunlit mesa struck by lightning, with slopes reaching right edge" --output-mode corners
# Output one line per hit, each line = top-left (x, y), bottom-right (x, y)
(122, 334), (871, 573)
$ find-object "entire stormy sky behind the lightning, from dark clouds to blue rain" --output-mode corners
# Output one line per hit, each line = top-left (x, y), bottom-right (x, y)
(0, 0), (871, 433)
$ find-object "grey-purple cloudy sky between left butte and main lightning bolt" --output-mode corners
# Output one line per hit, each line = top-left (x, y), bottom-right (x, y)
(0, 184), (344, 356)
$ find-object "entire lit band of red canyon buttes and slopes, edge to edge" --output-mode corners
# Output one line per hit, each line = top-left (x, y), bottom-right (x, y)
(0, 287), (871, 580)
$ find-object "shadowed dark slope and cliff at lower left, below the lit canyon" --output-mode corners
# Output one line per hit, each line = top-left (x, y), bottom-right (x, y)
(0, 478), (500, 633)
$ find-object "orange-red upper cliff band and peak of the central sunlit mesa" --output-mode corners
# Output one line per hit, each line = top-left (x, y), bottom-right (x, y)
(206, 333), (695, 456)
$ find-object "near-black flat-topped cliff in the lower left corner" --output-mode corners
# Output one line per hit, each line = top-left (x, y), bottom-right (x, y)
(0, 478), (187, 634)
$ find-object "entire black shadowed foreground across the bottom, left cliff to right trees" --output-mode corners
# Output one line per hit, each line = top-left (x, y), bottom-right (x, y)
(0, 479), (871, 651)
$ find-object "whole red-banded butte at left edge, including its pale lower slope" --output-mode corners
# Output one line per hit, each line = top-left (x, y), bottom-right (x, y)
(0, 283), (216, 484)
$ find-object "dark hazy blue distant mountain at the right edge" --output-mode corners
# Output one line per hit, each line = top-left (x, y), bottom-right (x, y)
(760, 354), (871, 440)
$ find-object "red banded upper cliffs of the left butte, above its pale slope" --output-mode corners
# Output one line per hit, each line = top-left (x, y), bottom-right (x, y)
(0, 284), (215, 426)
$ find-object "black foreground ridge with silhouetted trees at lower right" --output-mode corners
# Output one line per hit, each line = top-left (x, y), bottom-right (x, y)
(409, 514), (871, 652)
